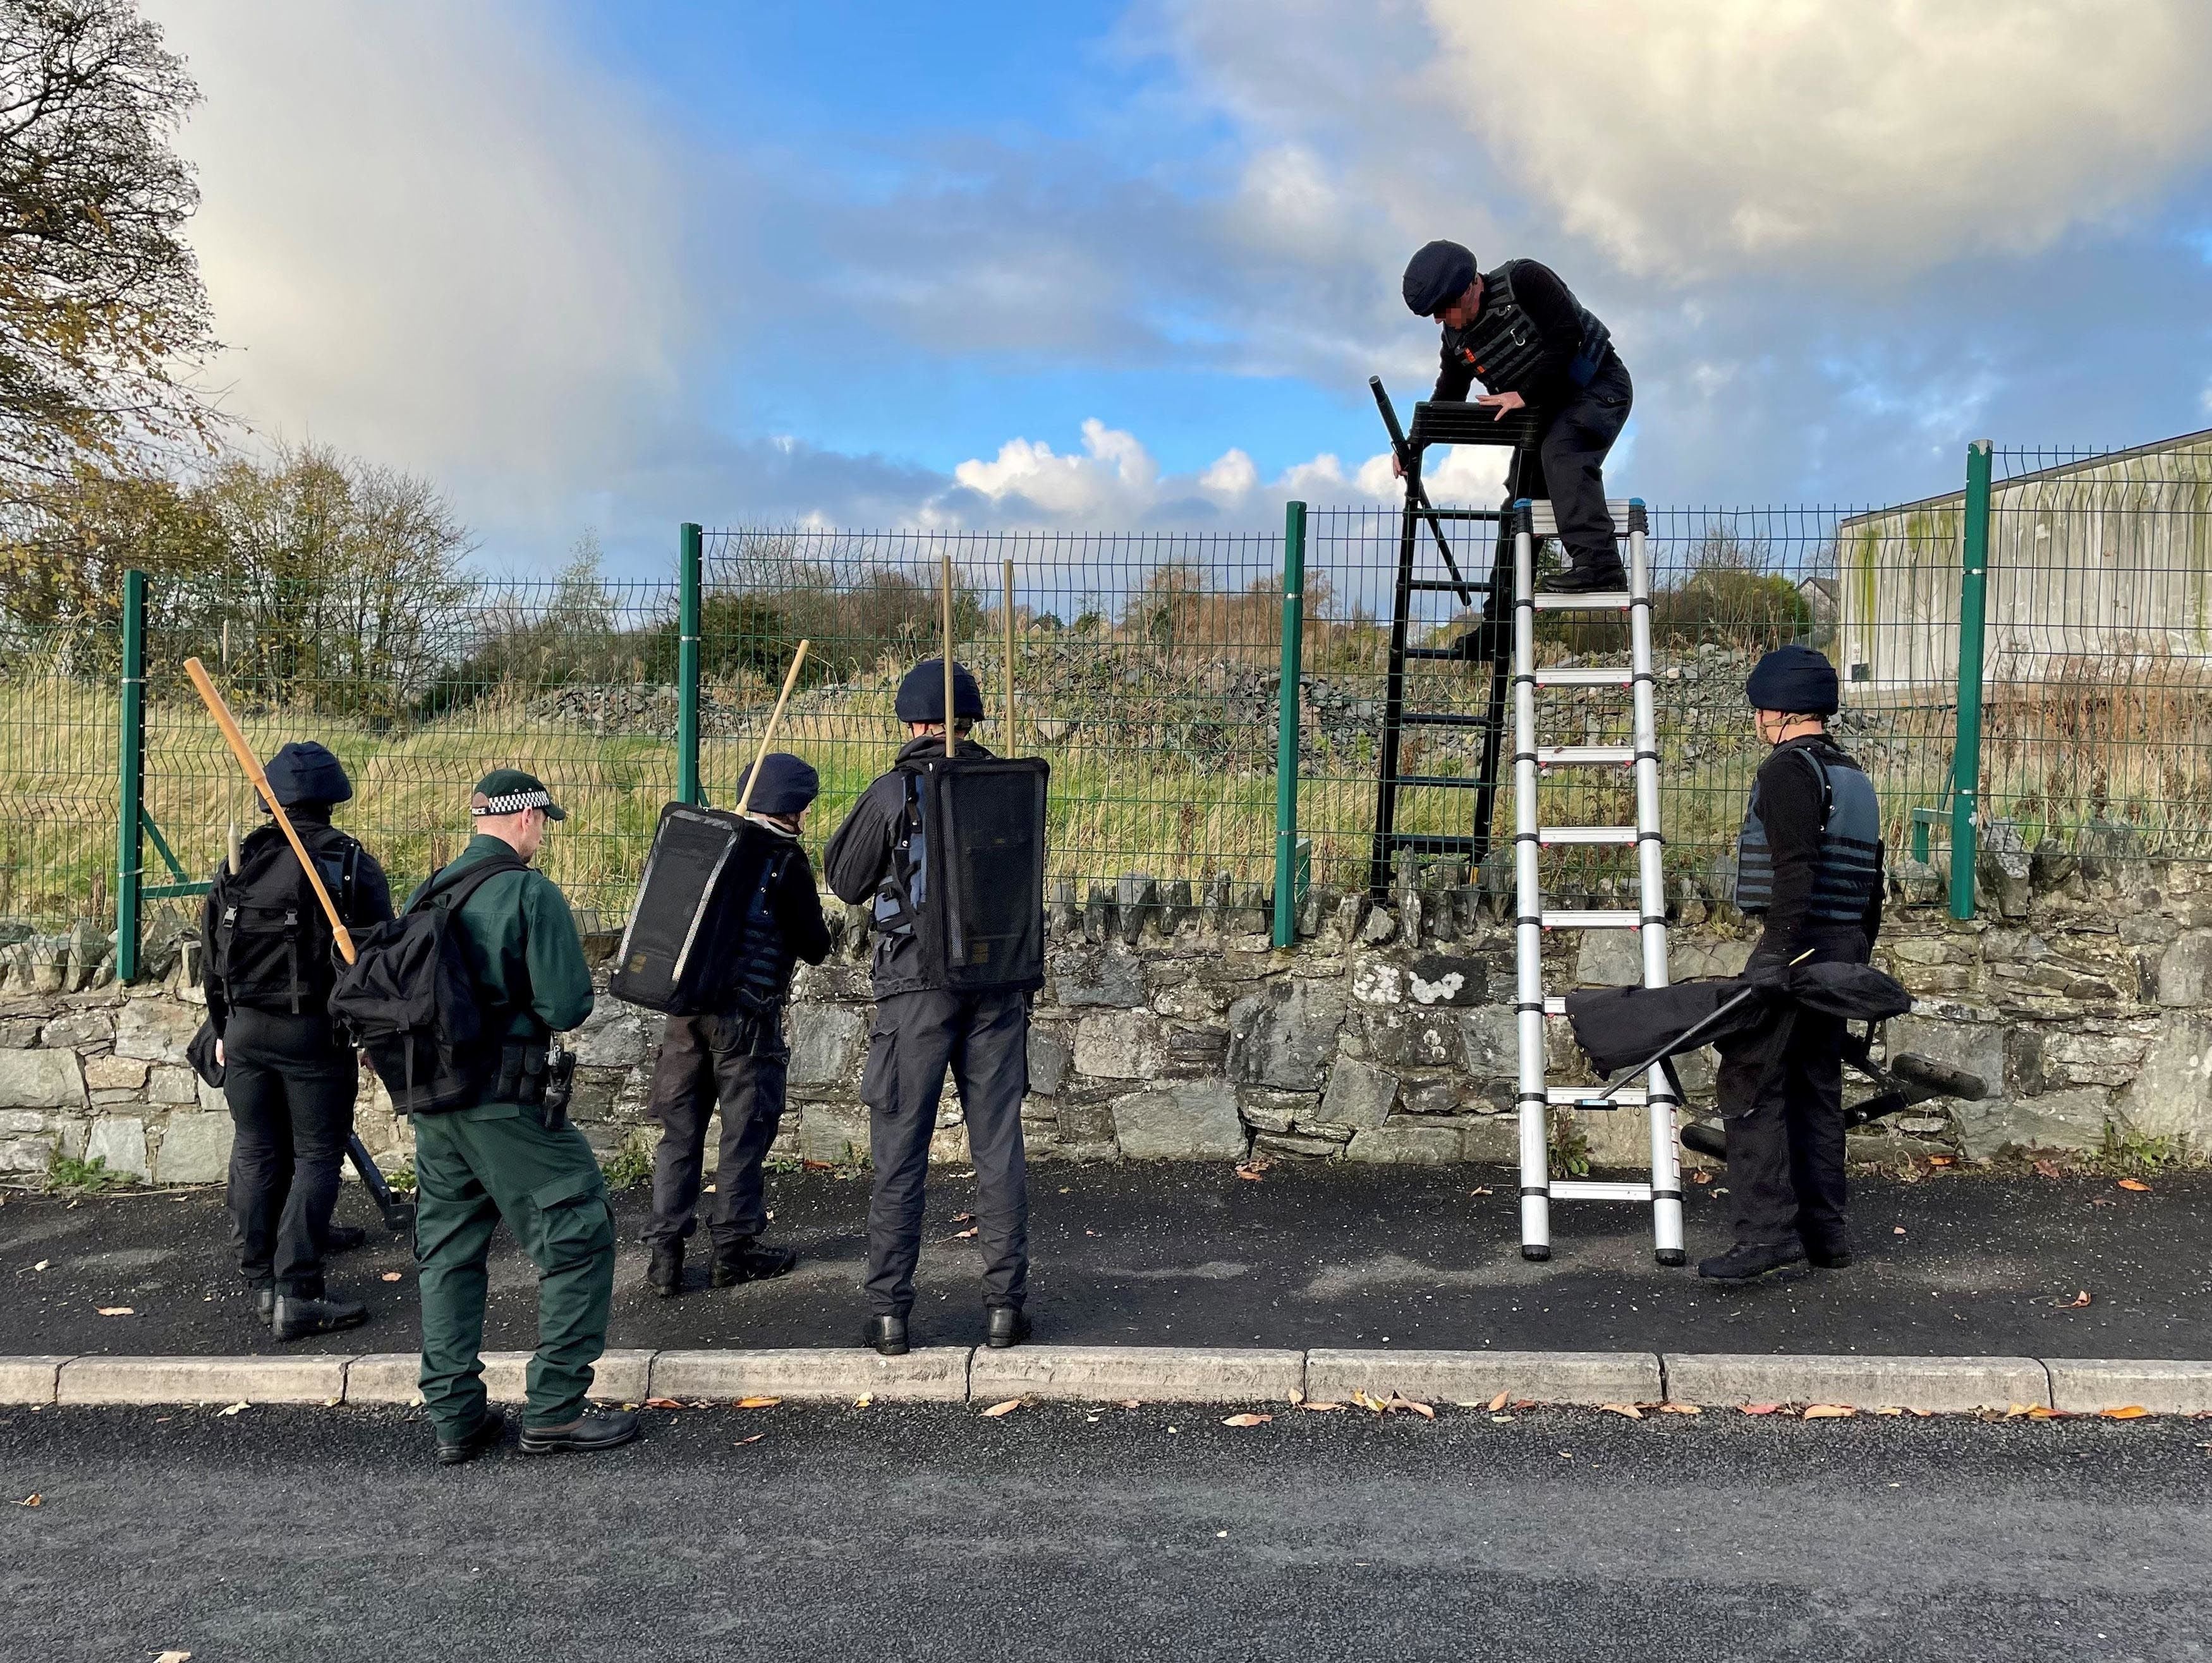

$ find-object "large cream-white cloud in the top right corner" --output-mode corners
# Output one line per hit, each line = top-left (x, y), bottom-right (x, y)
(1427, 0), (2212, 279)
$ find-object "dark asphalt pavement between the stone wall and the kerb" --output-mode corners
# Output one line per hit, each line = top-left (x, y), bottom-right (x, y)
(0, 1163), (2212, 1358)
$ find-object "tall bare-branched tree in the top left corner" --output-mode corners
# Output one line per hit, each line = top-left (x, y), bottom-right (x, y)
(0, 0), (215, 502)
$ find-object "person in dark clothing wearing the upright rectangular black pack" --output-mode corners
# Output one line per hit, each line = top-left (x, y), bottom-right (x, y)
(823, 659), (1029, 1356)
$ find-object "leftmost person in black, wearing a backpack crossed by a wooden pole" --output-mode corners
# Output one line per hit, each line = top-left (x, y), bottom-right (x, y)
(199, 741), (392, 1340)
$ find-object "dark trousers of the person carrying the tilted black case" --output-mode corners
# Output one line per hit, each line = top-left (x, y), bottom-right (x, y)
(644, 1013), (792, 1247)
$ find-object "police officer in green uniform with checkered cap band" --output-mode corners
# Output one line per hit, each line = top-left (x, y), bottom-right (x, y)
(410, 768), (637, 1466)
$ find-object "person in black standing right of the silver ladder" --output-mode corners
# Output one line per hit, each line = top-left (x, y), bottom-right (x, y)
(1697, 646), (1883, 1283)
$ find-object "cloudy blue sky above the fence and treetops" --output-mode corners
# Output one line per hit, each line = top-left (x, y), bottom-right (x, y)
(146, 0), (2212, 573)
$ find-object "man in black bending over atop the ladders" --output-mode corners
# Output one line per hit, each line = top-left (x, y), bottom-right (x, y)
(1394, 241), (1635, 595)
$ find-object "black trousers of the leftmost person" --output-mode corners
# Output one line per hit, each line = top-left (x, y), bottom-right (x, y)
(224, 1008), (361, 1298)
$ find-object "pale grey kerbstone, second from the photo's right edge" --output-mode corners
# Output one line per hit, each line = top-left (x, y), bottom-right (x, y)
(1662, 1352), (2051, 1411)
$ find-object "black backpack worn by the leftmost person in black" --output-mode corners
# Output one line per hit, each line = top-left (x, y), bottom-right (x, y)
(208, 825), (361, 1015)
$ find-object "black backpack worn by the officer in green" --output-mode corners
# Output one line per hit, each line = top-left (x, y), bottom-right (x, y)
(330, 854), (529, 1115)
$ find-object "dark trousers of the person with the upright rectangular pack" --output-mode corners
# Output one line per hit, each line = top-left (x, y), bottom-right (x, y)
(861, 993), (1029, 1316)
